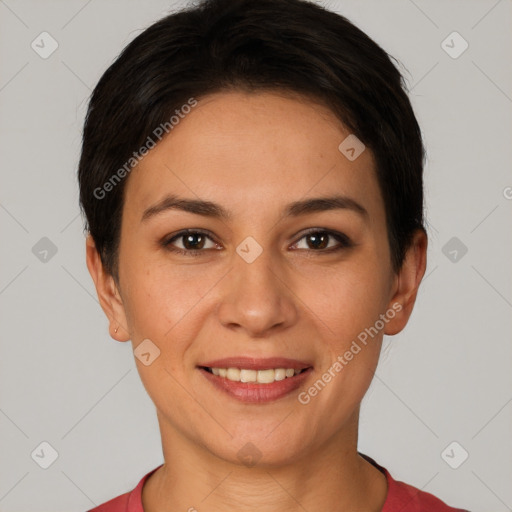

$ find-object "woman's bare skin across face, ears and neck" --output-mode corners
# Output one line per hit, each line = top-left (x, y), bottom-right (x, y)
(86, 92), (427, 512)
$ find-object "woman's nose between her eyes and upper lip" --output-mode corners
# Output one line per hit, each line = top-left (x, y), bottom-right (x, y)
(217, 246), (298, 338)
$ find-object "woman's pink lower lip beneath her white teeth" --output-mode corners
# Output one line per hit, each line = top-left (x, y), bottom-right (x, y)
(199, 368), (313, 403)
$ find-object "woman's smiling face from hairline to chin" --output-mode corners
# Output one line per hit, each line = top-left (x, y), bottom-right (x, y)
(89, 92), (424, 464)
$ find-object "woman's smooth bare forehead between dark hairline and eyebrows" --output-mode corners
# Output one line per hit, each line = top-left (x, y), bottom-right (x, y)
(125, 92), (382, 220)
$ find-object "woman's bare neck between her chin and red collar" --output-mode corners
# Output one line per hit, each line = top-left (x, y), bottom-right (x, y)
(142, 414), (387, 512)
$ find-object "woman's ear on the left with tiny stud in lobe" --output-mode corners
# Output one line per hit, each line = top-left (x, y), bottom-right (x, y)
(85, 235), (130, 341)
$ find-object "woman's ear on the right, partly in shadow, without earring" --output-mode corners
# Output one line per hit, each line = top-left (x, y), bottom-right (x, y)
(384, 229), (428, 336)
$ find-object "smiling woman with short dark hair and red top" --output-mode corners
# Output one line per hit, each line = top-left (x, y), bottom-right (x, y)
(79, 0), (472, 512)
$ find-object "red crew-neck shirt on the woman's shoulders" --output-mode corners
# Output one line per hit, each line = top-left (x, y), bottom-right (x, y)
(88, 456), (468, 512)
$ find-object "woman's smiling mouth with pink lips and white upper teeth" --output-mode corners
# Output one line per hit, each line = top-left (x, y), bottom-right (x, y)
(197, 357), (313, 403)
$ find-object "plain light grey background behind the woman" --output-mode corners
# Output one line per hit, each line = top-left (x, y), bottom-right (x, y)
(0, 0), (512, 512)
